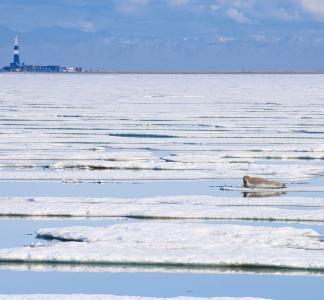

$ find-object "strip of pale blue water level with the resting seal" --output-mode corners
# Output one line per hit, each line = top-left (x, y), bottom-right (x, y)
(0, 178), (324, 198)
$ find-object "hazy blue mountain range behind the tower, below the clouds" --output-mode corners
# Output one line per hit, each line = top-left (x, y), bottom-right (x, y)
(0, 23), (324, 72)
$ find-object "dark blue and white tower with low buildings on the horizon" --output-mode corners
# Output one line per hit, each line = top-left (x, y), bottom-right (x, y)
(0, 36), (83, 73)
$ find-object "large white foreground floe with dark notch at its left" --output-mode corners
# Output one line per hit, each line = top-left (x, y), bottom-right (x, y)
(0, 222), (324, 271)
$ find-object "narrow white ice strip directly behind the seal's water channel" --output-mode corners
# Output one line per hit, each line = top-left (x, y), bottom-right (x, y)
(0, 161), (324, 182)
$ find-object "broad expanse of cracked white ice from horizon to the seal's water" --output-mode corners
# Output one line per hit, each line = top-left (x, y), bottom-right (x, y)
(0, 74), (324, 181)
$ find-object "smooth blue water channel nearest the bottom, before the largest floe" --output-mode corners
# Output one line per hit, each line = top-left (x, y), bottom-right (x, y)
(0, 271), (324, 300)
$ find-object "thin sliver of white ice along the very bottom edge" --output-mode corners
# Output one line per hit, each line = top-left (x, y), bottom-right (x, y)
(0, 294), (265, 300)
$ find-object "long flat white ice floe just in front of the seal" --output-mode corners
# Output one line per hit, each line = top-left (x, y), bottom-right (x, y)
(0, 195), (324, 222)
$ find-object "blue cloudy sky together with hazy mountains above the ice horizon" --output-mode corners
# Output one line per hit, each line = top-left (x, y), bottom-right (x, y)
(0, 0), (324, 72)
